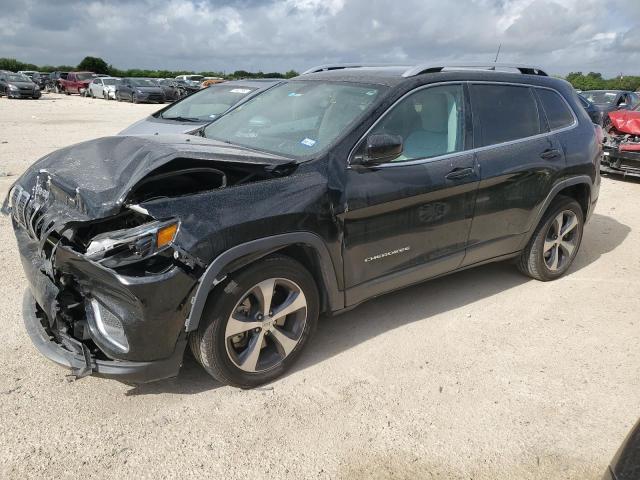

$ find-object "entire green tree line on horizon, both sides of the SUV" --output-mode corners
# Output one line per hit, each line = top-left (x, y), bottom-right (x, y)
(0, 57), (640, 91)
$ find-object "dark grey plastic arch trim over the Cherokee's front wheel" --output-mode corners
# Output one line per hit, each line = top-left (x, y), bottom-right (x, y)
(185, 232), (344, 332)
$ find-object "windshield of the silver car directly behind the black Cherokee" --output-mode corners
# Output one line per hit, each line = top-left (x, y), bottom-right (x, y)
(161, 85), (257, 122)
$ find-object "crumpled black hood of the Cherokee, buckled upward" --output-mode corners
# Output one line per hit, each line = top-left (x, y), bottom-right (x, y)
(8, 135), (295, 218)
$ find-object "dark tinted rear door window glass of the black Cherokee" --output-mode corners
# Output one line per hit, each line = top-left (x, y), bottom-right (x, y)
(470, 85), (541, 147)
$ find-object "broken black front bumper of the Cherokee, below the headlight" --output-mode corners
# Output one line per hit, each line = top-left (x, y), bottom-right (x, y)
(14, 220), (194, 383)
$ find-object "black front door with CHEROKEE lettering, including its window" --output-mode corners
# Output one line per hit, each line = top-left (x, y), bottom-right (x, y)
(340, 84), (478, 305)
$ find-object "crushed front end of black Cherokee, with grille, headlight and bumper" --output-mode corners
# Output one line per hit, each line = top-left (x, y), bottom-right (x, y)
(10, 178), (198, 383)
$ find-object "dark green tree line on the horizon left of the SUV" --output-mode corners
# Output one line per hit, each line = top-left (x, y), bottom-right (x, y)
(0, 57), (298, 80)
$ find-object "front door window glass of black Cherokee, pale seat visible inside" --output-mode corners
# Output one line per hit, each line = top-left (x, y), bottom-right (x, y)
(370, 85), (465, 162)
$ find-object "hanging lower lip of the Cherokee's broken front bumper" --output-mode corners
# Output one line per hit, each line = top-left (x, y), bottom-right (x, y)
(22, 289), (186, 383)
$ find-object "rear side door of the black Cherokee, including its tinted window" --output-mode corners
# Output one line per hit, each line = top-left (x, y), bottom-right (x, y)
(464, 83), (576, 266)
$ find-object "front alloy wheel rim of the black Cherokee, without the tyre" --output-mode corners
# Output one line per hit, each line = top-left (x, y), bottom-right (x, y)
(224, 278), (308, 373)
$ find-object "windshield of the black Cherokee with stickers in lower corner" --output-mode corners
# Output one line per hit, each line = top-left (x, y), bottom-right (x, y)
(205, 81), (386, 157)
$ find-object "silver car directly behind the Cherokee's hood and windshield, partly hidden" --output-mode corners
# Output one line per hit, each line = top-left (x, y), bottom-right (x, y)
(119, 79), (282, 135)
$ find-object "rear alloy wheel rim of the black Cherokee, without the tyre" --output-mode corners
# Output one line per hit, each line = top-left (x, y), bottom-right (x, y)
(543, 210), (580, 272)
